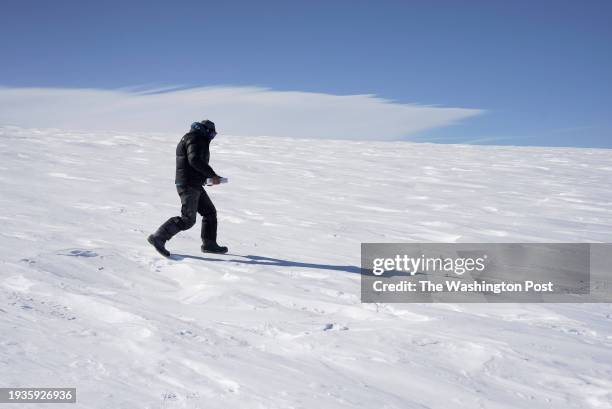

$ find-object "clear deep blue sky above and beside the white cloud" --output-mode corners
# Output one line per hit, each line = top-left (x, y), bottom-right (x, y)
(0, 0), (612, 148)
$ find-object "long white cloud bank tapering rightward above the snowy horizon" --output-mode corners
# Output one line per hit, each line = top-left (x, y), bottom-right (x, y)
(0, 86), (482, 140)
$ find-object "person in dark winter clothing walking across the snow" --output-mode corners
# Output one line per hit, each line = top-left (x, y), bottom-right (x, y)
(147, 119), (227, 257)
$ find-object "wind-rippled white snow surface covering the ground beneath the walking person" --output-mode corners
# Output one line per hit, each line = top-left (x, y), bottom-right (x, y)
(0, 126), (612, 409)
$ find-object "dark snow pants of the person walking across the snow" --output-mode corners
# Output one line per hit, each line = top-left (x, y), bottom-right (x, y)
(155, 186), (217, 244)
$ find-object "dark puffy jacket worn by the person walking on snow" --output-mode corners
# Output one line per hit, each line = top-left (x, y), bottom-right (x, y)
(174, 131), (218, 186)
